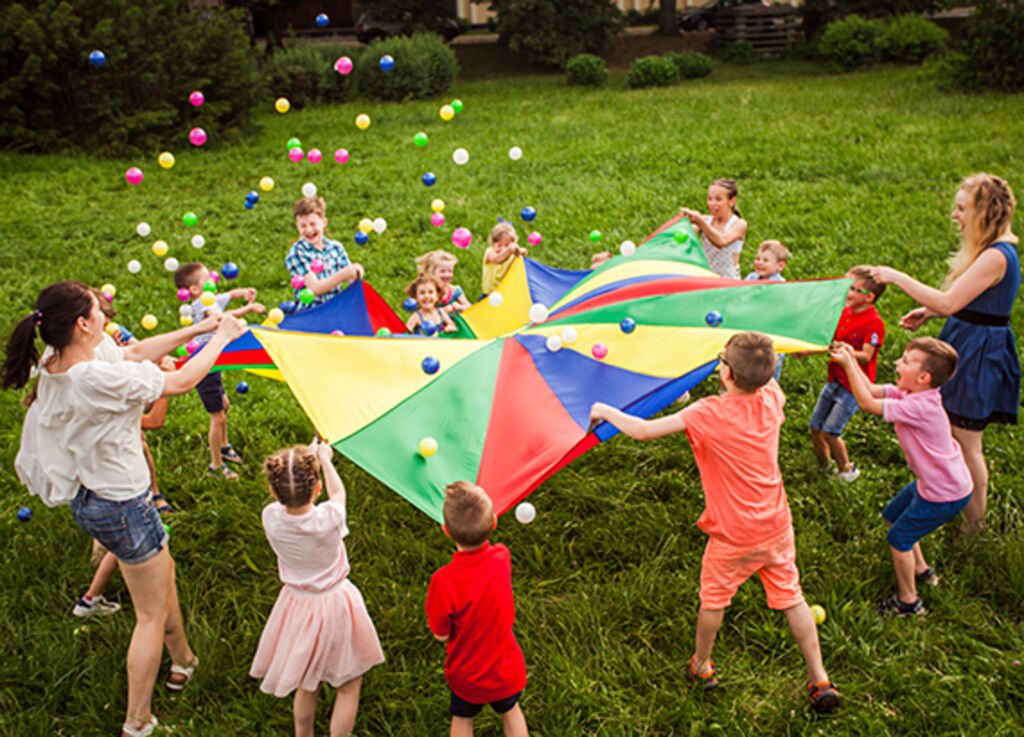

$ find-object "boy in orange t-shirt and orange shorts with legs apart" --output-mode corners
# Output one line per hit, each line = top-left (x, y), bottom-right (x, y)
(590, 332), (840, 711)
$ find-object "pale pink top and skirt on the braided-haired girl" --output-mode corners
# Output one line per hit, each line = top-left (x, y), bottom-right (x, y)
(249, 502), (384, 697)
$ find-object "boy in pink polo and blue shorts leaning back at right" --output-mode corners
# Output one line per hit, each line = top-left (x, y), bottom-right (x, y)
(833, 338), (972, 616)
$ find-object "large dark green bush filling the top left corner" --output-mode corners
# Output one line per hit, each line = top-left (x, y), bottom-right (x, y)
(0, 0), (260, 154)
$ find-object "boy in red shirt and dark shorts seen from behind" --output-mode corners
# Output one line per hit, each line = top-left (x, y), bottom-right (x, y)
(426, 481), (528, 737)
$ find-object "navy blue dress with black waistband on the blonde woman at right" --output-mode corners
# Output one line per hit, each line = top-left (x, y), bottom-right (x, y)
(939, 241), (1021, 430)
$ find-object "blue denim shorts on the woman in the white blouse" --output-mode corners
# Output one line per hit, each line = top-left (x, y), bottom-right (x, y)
(71, 486), (169, 564)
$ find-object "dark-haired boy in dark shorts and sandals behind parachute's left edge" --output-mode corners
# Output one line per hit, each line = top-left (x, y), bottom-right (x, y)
(174, 261), (266, 481)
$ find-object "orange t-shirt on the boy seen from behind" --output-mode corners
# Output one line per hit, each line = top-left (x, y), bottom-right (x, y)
(679, 385), (793, 548)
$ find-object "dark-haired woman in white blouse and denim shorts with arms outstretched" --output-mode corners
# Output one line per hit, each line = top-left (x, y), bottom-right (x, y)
(3, 281), (244, 737)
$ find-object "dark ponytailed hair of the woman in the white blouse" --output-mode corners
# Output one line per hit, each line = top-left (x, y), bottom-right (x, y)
(3, 281), (95, 389)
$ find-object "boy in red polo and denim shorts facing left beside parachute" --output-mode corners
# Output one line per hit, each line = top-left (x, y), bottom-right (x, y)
(808, 266), (886, 482)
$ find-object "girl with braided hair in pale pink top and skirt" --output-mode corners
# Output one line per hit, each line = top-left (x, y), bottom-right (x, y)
(249, 440), (384, 737)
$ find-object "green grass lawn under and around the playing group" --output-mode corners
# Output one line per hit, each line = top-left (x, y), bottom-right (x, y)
(0, 63), (1024, 737)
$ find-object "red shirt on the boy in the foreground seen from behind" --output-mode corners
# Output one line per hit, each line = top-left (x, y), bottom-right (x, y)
(426, 541), (526, 703)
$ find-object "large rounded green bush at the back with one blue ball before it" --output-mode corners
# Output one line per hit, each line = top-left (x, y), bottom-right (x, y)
(352, 33), (459, 101)
